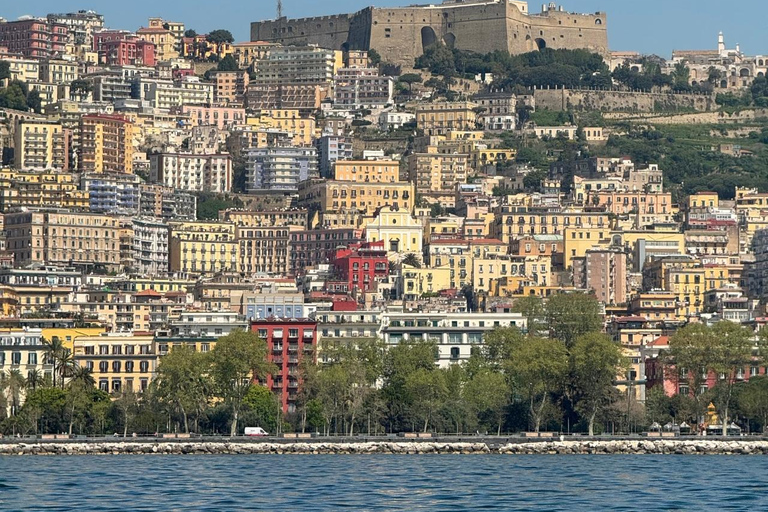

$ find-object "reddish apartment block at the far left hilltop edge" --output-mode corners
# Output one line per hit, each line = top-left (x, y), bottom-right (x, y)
(0, 18), (69, 59)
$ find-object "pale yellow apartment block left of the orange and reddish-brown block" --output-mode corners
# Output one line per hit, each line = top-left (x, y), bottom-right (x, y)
(13, 119), (71, 171)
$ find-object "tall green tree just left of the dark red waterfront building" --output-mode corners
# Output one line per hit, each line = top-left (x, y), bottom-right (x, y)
(211, 331), (274, 436)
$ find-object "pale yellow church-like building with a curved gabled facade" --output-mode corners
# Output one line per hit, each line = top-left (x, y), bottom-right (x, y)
(365, 206), (424, 259)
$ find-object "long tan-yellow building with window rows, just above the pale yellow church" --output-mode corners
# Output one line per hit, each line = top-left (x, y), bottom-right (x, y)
(298, 179), (414, 216)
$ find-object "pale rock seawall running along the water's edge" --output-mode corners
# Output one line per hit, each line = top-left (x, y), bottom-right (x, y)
(0, 439), (768, 456)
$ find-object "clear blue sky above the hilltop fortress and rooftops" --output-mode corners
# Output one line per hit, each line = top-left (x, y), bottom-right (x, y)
(0, 0), (768, 57)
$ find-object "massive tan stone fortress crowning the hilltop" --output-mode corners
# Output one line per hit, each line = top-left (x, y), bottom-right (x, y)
(251, 0), (608, 66)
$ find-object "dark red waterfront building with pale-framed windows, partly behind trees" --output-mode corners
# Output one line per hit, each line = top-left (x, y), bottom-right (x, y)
(251, 318), (317, 412)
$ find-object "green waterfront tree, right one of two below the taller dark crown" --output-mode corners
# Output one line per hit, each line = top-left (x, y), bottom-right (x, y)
(570, 332), (627, 436)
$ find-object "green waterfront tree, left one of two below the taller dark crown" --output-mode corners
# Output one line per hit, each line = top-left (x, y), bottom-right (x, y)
(510, 338), (568, 432)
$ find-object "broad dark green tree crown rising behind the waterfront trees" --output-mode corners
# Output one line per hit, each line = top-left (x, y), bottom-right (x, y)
(547, 293), (603, 348)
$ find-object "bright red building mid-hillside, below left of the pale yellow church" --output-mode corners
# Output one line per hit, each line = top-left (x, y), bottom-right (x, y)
(333, 240), (389, 292)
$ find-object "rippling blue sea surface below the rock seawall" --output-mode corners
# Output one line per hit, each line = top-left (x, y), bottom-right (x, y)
(0, 455), (768, 511)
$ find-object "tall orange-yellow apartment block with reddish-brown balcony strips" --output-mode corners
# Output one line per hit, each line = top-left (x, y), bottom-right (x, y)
(80, 114), (136, 173)
